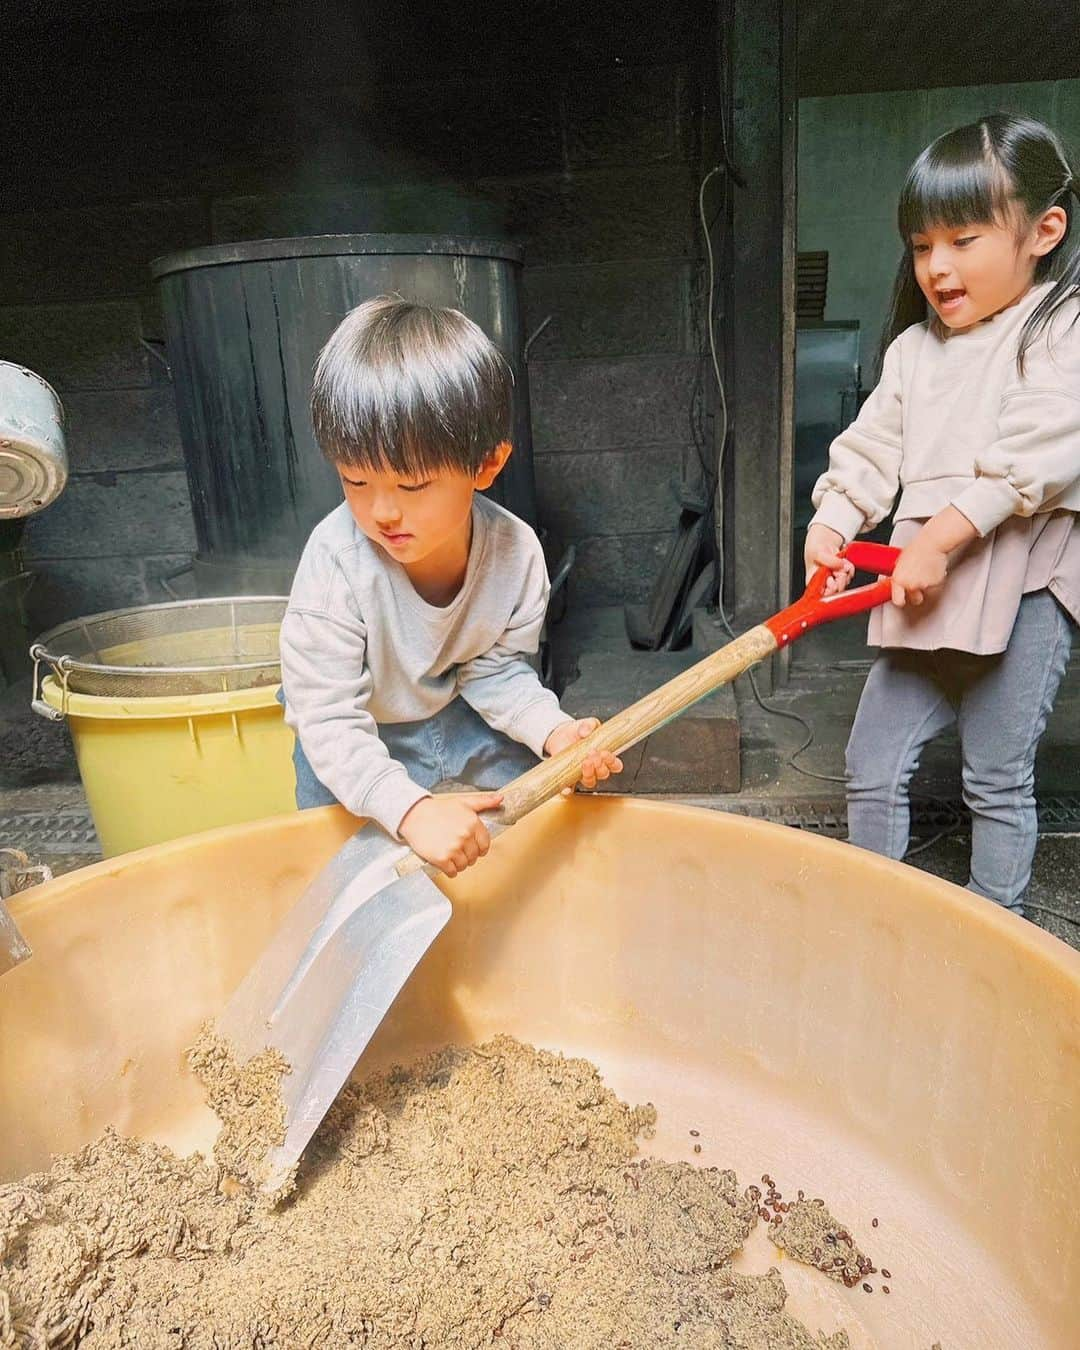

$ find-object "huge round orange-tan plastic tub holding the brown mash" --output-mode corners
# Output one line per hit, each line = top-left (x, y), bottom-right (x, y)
(0, 798), (1080, 1350)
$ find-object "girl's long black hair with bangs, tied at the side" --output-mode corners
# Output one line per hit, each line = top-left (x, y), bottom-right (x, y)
(878, 112), (1080, 373)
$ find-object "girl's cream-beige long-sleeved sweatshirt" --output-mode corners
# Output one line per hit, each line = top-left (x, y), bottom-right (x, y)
(813, 282), (1080, 540)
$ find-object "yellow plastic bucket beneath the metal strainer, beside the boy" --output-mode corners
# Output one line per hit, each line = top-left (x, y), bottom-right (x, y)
(42, 675), (296, 857)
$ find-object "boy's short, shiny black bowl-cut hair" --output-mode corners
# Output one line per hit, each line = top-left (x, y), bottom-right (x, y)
(312, 296), (513, 478)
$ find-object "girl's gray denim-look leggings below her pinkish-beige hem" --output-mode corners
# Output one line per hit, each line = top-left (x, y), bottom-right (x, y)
(848, 590), (1072, 910)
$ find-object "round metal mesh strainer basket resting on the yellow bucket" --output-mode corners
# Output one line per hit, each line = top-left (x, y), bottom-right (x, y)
(30, 595), (288, 706)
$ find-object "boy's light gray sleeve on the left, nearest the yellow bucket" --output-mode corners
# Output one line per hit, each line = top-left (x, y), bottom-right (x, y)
(281, 586), (429, 836)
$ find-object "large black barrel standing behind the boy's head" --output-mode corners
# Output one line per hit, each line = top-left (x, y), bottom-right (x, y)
(151, 235), (536, 591)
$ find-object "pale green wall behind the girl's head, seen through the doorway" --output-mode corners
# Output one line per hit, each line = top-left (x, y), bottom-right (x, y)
(798, 80), (1080, 385)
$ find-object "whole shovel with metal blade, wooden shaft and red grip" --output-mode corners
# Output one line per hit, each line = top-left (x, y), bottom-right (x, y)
(216, 543), (899, 1195)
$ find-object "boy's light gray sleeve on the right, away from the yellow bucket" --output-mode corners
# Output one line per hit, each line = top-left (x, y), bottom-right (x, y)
(458, 543), (574, 756)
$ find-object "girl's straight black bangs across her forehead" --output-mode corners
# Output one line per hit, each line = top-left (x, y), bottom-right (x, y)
(896, 138), (1010, 243)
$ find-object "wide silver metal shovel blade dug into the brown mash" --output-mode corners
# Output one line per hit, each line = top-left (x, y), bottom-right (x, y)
(216, 829), (452, 1193)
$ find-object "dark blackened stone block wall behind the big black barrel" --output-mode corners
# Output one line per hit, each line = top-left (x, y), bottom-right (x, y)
(8, 0), (714, 625)
